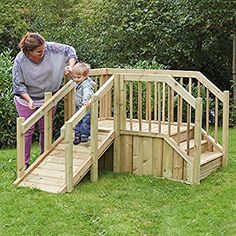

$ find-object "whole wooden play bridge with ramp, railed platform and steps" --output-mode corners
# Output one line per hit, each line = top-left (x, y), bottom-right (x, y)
(15, 68), (229, 193)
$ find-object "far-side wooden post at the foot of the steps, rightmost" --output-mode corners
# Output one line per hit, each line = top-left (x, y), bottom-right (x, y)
(222, 91), (229, 166)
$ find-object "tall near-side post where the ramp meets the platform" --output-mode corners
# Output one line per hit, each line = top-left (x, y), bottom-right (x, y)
(113, 74), (120, 172)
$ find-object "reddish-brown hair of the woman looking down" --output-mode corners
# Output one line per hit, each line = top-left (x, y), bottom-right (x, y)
(19, 32), (45, 53)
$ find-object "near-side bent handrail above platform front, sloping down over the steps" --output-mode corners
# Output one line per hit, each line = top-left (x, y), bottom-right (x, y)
(121, 74), (196, 108)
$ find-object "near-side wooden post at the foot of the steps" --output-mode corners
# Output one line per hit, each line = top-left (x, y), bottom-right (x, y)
(192, 98), (202, 184)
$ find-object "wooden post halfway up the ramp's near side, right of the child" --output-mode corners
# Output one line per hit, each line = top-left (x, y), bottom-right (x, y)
(90, 96), (98, 182)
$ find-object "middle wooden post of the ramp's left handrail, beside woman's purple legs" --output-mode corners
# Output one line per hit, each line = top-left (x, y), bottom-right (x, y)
(44, 92), (52, 151)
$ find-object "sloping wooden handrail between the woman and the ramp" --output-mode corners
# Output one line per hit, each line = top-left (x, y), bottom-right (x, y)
(21, 80), (74, 134)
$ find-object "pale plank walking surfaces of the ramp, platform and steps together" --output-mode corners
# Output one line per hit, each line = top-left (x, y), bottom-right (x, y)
(15, 119), (222, 193)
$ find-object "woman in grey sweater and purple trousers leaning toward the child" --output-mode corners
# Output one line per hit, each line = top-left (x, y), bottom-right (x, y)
(12, 33), (76, 169)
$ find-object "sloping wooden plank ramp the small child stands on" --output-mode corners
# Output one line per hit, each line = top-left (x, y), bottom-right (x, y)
(15, 122), (115, 193)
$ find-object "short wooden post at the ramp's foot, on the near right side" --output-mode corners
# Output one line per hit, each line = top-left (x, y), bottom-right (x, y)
(65, 122), (73, 192)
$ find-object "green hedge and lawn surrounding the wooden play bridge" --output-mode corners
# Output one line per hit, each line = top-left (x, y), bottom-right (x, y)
(0, 0), (236, 236)
